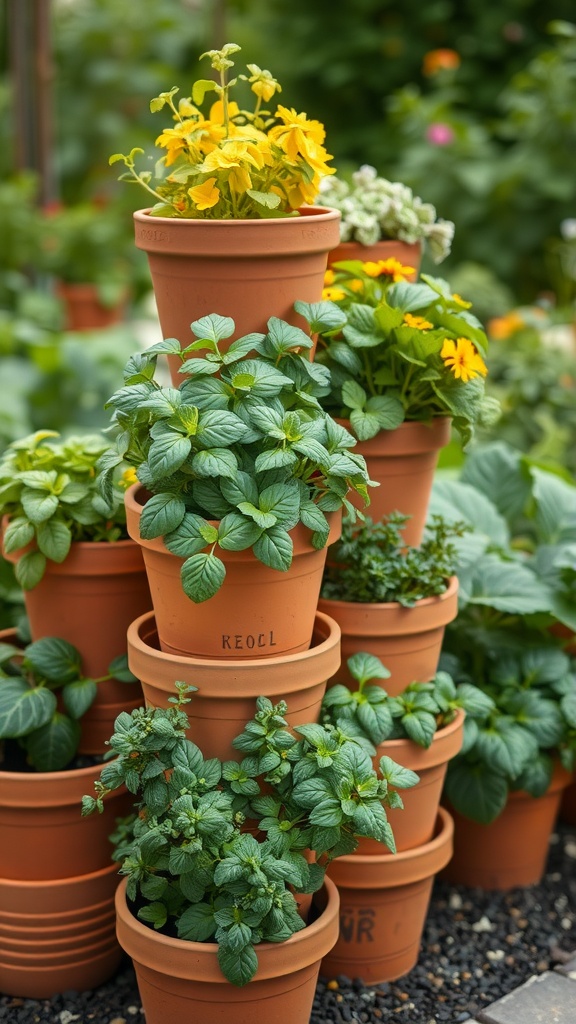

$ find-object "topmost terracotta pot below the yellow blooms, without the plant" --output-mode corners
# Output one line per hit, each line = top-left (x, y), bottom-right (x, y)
(134, 207), (340, 384)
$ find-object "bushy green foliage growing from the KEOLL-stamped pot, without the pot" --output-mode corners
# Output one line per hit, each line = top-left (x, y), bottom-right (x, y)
(98, 307), (369, 602)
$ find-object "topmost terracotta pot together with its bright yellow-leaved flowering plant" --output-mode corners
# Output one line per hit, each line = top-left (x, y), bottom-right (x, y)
(111, 43), (340, 372)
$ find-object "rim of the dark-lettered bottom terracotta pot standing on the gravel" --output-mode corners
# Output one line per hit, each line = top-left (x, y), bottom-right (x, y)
(329, 807), (454, 889)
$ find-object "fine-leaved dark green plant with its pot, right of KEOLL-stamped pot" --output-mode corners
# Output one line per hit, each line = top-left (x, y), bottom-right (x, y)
(319, 512), (462, 695)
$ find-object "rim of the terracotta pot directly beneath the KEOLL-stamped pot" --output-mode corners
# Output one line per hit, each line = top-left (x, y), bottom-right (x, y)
(127, 611), (341, 697)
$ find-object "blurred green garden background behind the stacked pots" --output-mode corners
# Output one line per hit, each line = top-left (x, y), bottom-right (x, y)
(0, 0), (576, 626)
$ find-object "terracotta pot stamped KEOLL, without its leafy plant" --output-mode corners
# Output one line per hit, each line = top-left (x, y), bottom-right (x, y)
(125, 484), (341, 671)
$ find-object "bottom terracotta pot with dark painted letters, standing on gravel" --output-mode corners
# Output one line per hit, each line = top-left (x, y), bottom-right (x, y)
(321, 808), (452, 985)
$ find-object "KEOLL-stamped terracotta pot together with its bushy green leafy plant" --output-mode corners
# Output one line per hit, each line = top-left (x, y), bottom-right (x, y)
(99, 313), (369, 658)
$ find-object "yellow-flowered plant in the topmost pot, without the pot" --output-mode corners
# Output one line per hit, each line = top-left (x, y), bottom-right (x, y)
(110, 43), (334, 219)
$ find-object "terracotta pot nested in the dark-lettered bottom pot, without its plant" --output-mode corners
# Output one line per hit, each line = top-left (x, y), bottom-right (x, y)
(355, 708), (465, 856)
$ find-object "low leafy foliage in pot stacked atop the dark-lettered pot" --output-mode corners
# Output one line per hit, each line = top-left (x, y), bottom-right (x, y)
(322, 651), (492, 754)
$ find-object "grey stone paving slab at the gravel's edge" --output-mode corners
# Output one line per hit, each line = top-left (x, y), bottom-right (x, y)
(477, 962), (576, 1024)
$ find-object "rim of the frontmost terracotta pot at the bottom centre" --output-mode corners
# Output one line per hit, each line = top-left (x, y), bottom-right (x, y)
(115, 877), (340, 985)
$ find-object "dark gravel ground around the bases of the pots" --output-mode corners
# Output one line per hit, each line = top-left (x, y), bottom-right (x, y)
(0, 825), (576, 1024)
